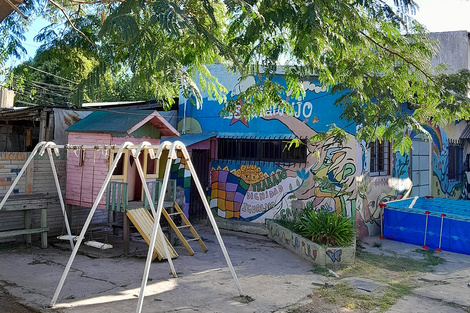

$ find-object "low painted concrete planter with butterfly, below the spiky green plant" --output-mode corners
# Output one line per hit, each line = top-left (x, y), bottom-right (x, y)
(266, 220), (356, 266)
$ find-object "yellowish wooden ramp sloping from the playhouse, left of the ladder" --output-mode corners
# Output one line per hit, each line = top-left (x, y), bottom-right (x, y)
(126, 208), (178, 261)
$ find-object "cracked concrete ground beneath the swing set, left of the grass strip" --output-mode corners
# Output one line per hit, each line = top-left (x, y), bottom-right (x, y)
(0, 225), (328, 313)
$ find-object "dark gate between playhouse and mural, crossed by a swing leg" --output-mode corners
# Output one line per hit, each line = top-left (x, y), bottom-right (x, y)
(189, 149), (210, 221)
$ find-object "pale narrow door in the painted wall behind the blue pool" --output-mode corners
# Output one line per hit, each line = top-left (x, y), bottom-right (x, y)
(411, 138), (431, 197)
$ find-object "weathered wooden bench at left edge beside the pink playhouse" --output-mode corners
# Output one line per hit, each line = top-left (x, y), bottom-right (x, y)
(0, 194), (54, 248)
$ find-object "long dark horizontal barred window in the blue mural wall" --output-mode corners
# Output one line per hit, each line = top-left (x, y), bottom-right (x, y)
(218, 138), (307, 163)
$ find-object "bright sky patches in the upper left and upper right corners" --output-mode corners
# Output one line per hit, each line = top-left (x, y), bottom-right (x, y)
(7, 0), (470, 63)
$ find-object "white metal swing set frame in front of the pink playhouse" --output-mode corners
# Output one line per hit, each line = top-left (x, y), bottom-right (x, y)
(0, 141), (244, 313)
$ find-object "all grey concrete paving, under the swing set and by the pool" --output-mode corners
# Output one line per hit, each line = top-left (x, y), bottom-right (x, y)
(0, 225), (470, 313)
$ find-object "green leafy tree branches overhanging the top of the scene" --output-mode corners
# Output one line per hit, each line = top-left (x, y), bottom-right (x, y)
(0, 0), (470, 152)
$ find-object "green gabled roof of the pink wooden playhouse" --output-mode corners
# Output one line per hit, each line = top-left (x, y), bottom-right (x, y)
(66, 110), (179, 137)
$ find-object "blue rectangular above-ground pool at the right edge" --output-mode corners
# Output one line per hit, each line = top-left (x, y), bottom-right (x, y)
(383, 197), (470, 254)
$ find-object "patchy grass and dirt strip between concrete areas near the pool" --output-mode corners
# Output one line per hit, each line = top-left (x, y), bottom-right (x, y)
(287, 248), (443, 313)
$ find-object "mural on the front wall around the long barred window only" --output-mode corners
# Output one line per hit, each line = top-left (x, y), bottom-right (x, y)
(180, 67), (364, 227)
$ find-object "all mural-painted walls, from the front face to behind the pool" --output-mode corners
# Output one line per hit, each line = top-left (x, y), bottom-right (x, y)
(175, 66), (470, 237)
